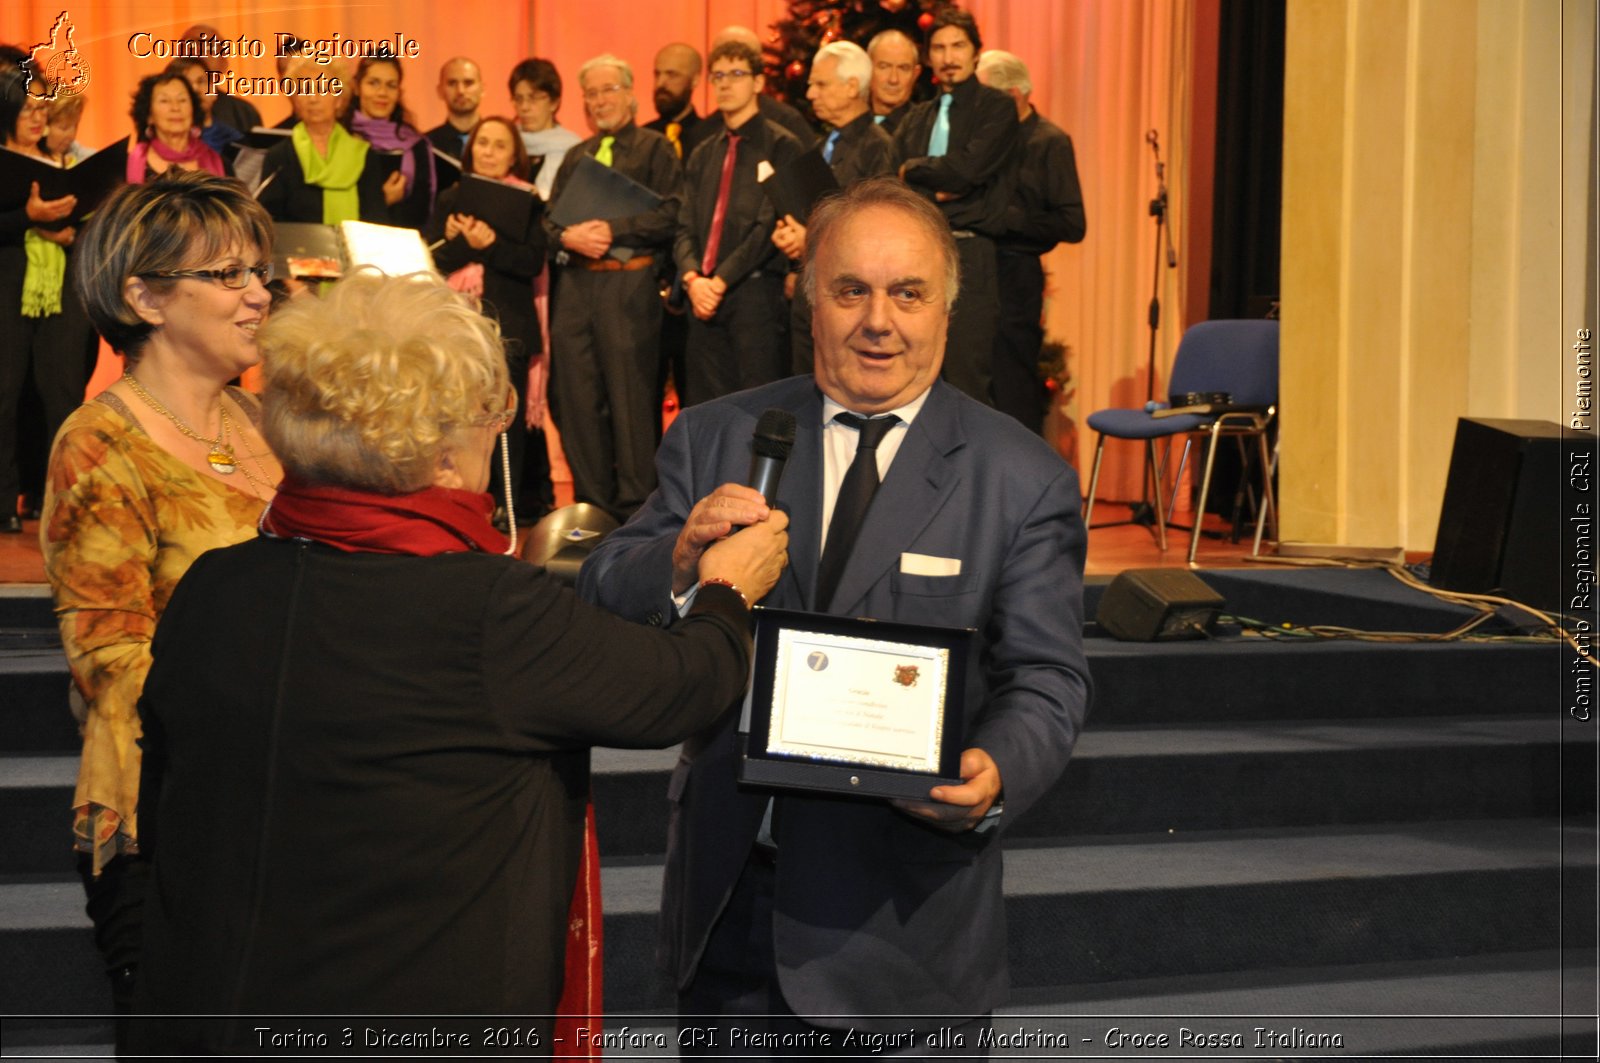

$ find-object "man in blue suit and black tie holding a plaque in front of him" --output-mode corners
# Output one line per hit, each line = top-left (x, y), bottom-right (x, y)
(579, 178), (1088, 1055)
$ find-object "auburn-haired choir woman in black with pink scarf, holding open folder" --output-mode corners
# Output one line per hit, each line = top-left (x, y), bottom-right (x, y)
(424, 117), (555, 523)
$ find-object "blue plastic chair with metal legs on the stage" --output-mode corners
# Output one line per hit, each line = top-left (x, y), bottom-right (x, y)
(1083, 320), (1278, 565)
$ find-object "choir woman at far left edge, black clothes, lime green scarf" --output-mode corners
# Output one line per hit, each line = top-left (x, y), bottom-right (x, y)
(0, 69), (94, 535)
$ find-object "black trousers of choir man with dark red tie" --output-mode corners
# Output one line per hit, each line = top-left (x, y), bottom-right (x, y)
(678, 271), (789, 407)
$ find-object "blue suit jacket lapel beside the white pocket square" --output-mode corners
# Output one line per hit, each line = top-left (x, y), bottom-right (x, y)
(808, 383), (963, 615)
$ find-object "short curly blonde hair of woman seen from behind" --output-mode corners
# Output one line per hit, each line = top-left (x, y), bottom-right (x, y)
(261, 269), (510, 495)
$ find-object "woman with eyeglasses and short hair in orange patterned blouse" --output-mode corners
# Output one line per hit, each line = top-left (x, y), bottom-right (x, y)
(40, 168), (282, 1030)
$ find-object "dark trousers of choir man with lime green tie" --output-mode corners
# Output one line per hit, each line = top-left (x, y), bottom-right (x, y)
(550, 267), (661, 520)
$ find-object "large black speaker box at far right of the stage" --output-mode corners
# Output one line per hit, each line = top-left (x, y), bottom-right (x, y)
(1429, 418), (1565, 608)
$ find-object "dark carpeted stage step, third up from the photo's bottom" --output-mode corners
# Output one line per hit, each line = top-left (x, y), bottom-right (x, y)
(0, 717), (1574, 874)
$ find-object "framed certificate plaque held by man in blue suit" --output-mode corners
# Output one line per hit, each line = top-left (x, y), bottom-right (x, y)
(739, 607), (973, 800)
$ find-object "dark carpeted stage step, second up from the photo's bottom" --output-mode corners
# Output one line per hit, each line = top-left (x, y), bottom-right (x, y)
(0, 820), (1595, 1013)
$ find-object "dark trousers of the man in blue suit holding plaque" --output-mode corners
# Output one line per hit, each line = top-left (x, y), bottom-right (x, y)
(678, 848), (992, 1060)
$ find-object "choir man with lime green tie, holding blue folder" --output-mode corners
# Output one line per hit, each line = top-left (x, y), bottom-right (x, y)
(544, 54), (682, 519)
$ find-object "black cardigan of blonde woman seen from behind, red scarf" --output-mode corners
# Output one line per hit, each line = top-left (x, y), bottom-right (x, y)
(138, 538), (750, 1053)
